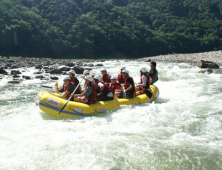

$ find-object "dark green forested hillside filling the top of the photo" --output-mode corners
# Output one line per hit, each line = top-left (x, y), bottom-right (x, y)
(0, 0), (222, 58)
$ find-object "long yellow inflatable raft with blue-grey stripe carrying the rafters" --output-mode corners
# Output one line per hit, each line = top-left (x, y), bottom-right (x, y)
(35, 85), (159, 117)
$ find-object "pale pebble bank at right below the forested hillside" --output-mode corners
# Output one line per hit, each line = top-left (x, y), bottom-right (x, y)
(138, 50), (222, 66)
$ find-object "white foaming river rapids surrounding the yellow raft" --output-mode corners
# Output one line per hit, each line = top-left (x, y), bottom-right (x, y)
(0, 61), (222, 170)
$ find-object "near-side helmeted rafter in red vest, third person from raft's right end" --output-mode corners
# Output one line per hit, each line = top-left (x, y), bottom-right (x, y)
(116, 70), (135, 98)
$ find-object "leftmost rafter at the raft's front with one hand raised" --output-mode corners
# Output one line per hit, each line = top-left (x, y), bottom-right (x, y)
(55, 77), (77, 100)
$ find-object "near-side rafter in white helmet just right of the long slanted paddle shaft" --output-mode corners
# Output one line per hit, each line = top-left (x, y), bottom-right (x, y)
(72, 75), (97, 104)
